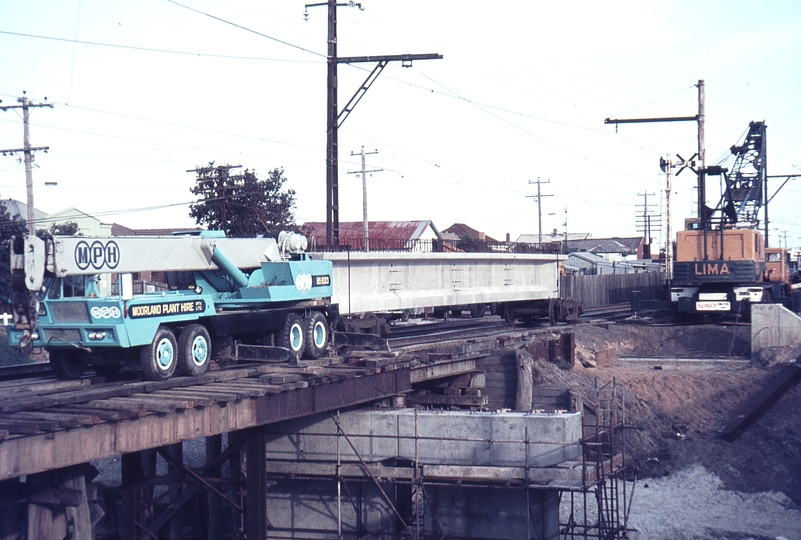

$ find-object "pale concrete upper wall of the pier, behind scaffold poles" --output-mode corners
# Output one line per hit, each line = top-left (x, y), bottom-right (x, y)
(267, 409), (581, 469)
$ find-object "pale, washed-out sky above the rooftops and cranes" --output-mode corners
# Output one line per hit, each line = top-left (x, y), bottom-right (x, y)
(0, 0), (801, 247)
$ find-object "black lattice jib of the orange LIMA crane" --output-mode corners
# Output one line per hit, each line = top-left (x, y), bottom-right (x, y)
(721, 122), (767, 229)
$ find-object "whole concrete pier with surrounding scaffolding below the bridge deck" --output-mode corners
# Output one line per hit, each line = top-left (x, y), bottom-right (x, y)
(266, 389), (625, 540)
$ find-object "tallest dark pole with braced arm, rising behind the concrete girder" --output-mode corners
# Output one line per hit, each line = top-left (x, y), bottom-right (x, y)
(306, 0), (442, 249)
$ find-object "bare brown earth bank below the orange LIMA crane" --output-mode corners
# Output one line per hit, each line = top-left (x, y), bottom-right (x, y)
(535, 324), (801, 505)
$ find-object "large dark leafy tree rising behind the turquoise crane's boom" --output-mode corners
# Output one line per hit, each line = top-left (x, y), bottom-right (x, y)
(189, 162), (296, 237)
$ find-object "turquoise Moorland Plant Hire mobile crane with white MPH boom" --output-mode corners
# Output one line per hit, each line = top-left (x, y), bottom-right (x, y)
(8, 231), (339, 380)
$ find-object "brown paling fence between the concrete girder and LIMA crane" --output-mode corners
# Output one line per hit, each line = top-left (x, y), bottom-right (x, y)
(560, 272), (667, 309)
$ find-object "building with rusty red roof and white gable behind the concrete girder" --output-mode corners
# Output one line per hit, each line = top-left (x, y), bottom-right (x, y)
(300, 220), (442, 252)
